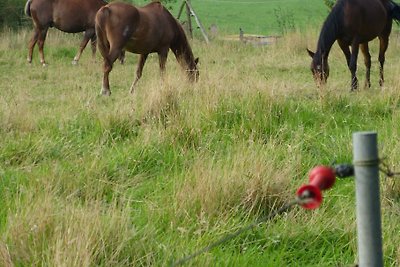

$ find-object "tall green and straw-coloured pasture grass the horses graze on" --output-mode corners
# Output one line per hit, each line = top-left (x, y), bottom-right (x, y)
(0, 1), (400, 266)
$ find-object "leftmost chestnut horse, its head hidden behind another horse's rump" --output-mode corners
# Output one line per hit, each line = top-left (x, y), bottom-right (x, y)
(25, 0), (107, 66)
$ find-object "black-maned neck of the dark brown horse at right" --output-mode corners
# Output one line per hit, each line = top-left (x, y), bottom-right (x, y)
(317, 10), (341, 58)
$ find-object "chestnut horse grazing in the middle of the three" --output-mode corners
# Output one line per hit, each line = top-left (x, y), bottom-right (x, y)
(95, 1), (199, 95)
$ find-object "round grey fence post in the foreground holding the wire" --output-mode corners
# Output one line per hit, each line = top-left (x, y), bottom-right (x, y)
(353, 132), (383, 267)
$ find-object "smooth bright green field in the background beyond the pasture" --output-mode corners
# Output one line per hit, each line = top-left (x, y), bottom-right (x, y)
(132, 0), (328, 35)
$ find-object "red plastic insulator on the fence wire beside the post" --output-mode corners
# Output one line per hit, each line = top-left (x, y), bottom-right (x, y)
(296, 166), (336, 209)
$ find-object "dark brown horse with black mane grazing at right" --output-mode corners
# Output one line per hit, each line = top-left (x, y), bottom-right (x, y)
(307, 0), (400, 91)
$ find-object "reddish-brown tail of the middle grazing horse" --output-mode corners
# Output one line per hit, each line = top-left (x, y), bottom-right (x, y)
(95, 6), (111, 58)
